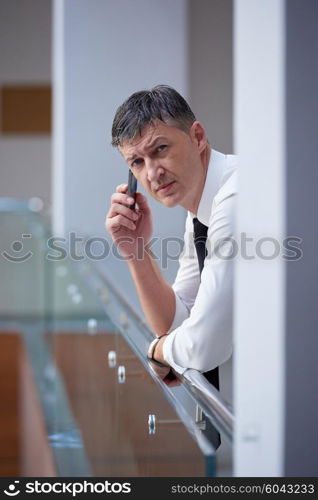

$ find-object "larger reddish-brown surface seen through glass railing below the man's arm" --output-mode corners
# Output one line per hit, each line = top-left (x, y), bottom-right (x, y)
(51, 331), (206, 477)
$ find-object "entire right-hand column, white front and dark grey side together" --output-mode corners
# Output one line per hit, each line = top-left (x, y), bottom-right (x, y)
(234, 0), (318, 477)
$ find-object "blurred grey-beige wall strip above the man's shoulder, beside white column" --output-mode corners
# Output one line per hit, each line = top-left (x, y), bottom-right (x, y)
(188, 0), (233, 153)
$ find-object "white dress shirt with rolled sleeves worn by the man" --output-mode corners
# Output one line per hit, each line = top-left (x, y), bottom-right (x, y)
(163, 150), (237, 374)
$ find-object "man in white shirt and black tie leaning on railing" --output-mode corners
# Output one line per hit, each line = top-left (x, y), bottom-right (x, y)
(106, 85), (237, 388)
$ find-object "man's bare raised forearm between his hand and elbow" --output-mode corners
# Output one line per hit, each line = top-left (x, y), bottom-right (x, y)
(128, 244), (176, 335)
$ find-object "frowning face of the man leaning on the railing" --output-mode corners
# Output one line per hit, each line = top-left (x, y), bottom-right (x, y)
(119, 120), (201, 207)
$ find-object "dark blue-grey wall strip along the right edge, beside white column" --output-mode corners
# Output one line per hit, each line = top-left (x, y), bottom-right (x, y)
(285, 0), (318, 477)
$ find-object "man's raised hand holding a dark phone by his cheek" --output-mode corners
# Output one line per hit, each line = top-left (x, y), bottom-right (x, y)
(105, 175), (152, 259)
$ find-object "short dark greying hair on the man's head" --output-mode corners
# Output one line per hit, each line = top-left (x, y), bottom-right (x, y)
(112, 85), (196, 147)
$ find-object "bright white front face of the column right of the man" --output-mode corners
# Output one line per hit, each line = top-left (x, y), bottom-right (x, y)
(234, 0), (285, 476)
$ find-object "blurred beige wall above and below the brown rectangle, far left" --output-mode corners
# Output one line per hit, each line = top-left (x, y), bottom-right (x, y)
(0, 0), (52, 205)
